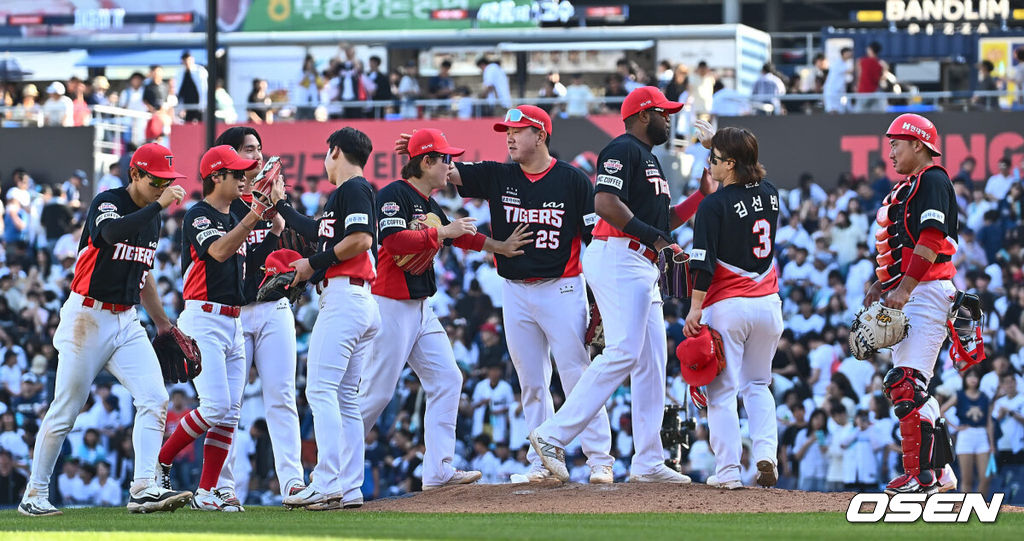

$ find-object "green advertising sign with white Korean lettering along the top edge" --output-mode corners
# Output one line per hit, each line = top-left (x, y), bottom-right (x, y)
(242, 0), (557, 32)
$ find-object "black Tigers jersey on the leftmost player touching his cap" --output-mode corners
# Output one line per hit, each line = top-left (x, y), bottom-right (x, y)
(71, 188), (160, 305)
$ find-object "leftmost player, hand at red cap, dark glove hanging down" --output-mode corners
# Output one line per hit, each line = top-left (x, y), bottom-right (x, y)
(17, 143), (191, 516)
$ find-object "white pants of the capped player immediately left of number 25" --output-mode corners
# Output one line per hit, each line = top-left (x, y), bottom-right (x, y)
(359, 295), (462, 486)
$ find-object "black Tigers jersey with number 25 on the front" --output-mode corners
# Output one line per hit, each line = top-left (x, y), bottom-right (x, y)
(456, 159), (597, 280)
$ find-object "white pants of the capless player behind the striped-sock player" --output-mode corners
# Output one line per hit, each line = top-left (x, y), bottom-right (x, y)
(217, 298), (305, 496)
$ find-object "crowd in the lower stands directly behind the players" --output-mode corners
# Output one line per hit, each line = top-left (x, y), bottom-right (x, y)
(0, 135), (1024, 506)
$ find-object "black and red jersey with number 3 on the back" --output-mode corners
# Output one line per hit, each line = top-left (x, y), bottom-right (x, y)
(690, 180), (779, 306)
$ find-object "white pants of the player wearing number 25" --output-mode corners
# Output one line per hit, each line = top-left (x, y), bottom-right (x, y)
(502, 276), (614, 466)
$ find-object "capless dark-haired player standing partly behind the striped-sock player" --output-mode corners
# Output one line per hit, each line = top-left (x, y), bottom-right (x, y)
(214, 126), (305, 503)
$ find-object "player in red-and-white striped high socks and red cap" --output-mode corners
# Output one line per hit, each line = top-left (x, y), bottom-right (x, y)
(153, 144), (270, 511)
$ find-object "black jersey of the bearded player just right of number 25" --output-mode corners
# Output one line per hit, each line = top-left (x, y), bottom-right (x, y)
(594, 133), (672, 242)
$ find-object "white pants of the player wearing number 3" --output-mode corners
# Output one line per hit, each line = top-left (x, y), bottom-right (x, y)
(700, 293), (782, 482)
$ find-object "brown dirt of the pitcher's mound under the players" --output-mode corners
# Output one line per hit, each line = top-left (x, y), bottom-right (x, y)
(362, 480), (854, 513)
